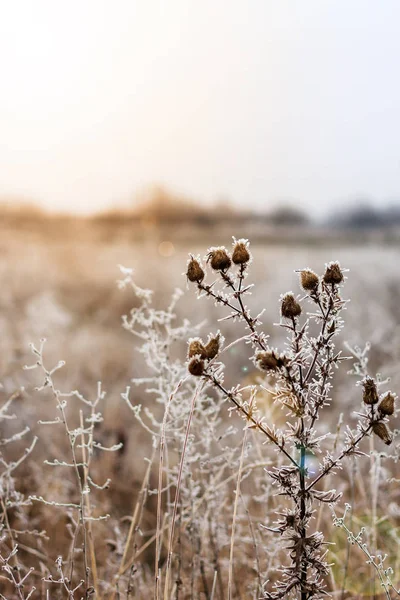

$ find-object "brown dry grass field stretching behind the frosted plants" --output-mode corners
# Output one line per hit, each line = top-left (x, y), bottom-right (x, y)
(0, 221), (400, 600)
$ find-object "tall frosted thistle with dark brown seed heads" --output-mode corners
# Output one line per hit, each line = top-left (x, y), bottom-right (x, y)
(186, 239), (395, 600)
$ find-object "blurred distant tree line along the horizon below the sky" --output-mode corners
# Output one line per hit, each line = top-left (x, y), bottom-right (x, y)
(0, 186), (400, 230)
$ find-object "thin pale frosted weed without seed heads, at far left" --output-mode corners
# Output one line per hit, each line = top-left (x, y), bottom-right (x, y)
(25, 338), (122, 600)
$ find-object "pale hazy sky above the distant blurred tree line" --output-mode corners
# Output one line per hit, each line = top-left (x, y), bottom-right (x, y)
(0, 0), (400, 214)
